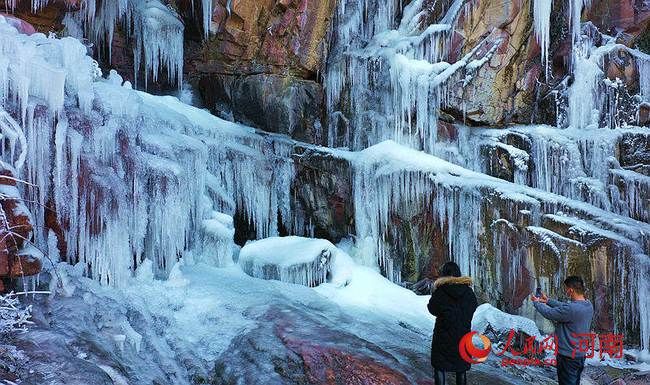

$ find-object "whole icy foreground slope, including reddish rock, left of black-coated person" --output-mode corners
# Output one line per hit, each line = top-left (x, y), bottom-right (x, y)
(10, 255), (545, 385)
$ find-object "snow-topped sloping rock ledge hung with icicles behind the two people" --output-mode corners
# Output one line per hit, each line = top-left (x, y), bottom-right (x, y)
(354, 142), (650, 347)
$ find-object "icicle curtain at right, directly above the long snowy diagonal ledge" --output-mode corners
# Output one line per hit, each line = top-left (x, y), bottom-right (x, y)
(428, 125), (650, 222)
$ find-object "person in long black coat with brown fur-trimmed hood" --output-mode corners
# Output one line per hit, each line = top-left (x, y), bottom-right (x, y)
(427, 262), (478, 385)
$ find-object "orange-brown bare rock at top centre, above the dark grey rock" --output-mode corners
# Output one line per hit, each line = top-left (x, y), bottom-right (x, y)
(187, 0), (335, 78)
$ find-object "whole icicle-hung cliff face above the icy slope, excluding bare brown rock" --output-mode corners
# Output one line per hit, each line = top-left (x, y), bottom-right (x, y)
(0, 0), (650, 360)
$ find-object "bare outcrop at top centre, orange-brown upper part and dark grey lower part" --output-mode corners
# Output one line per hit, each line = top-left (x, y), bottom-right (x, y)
(179, 0), (335, 143)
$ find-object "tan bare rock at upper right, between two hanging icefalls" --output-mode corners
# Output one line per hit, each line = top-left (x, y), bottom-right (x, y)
(442, 0), (544, 125)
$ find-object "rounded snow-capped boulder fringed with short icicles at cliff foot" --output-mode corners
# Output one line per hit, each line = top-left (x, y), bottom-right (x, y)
(239, 237), (338, 287)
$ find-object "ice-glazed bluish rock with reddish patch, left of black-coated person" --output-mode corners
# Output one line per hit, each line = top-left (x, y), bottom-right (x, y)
(208, 304), (528, 385)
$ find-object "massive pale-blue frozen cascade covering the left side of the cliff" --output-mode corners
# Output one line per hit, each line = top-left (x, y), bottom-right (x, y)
(0, 18), (293, 285)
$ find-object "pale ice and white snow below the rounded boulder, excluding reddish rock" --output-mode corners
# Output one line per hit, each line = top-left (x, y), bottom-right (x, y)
(41, 246), (433, 384)
